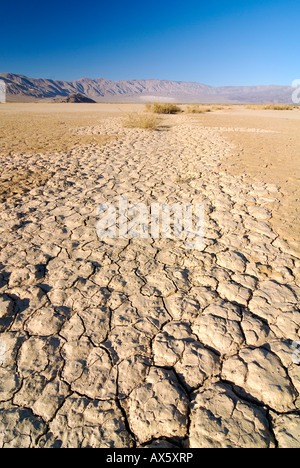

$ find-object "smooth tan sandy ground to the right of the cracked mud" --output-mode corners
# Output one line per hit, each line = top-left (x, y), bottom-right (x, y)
(182, 106), (300, 251)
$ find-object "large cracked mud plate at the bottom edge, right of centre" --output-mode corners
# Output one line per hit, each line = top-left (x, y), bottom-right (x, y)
(187, 382), (274, 448)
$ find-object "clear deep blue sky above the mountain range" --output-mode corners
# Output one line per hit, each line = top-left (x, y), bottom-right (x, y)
(0, 0), (300, 86)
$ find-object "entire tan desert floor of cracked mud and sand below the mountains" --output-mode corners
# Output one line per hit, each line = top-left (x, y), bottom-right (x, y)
(0, 103), (300, 448)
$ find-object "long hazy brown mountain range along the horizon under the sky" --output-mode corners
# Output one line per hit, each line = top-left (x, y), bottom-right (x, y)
(0, 73), (294, 104)
